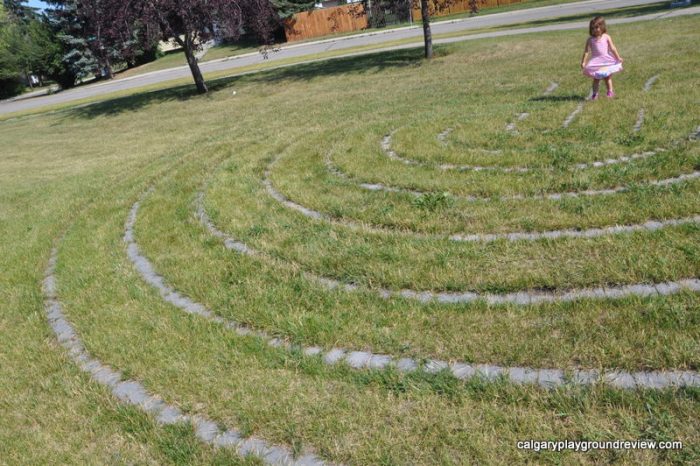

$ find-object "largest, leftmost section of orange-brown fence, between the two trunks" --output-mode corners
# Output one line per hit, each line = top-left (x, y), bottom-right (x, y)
(284, 3), (368, 42)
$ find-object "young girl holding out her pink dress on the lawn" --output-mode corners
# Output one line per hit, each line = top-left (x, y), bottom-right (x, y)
(581, 16), (622, 100)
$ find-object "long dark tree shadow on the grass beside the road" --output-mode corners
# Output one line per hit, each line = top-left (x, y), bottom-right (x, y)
(65, 49), (423, 119)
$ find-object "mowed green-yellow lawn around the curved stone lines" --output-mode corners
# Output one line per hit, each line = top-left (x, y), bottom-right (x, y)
(0, 12), (700, 465)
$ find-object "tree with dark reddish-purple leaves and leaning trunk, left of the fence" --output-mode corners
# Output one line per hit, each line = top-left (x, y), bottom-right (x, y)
(123, 0), (279, 93)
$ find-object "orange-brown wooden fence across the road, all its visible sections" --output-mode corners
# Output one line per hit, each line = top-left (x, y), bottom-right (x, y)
(284, 0), (522, 42)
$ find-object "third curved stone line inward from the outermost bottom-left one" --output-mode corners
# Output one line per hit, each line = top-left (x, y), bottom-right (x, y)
(193, 186), (700, 306)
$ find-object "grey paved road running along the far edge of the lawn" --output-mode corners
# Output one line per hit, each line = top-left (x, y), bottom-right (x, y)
(0, 0), (700, 114)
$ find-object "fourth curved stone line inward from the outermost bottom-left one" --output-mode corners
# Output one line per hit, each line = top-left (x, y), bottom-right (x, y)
(262, 160), (700, 242)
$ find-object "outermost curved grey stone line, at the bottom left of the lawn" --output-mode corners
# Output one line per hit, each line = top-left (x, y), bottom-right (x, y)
(42, 242), (327, 466)
